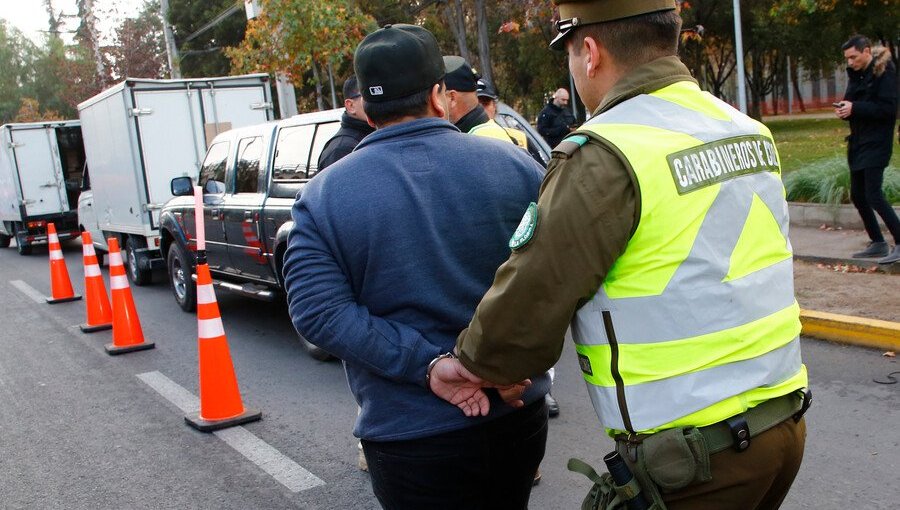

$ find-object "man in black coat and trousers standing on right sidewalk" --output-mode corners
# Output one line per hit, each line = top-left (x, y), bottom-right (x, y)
(834, 35), (900, 264)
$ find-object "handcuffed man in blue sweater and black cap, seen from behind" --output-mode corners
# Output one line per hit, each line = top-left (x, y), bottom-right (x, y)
(284, 24), (550, 510)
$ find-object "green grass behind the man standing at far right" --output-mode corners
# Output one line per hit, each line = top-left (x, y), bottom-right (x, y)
(766, 119), (900, 205)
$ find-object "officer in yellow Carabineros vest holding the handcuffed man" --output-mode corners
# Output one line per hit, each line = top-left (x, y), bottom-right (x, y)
(432, 0), (809, 509)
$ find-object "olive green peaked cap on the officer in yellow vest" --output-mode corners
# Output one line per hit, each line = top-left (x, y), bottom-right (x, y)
(550, 0), (675, 50)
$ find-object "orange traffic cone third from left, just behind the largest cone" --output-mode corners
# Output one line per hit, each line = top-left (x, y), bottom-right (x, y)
(106, 237), (155, 355)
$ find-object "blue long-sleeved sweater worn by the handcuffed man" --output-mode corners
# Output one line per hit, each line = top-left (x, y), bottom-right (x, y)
(284, 119), (550, 441)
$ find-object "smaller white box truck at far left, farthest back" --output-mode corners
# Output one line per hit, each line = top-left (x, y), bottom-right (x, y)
(0, 120), (85, 255)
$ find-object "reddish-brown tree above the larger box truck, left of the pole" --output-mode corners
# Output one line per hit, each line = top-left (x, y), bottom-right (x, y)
(104, 1), (169, 78)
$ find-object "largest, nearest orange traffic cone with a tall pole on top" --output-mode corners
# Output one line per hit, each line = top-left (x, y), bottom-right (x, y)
(184, 264), (262, 432)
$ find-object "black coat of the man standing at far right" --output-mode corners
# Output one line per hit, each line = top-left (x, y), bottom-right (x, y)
(844, 46), (897, 170)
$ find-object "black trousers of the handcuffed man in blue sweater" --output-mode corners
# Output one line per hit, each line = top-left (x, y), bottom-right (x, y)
(362, 399), (547, 510)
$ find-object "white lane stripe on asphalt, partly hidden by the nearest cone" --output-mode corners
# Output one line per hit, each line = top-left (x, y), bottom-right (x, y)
(137, 371), (325, 492)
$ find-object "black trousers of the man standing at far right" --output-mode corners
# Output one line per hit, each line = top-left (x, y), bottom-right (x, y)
(850, 168), (900, 244)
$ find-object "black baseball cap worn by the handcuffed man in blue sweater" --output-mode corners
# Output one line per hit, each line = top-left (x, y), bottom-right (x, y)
(353, 24), (446, 103)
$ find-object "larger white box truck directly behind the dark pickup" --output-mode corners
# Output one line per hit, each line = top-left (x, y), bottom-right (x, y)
(78, 74), (273, 285)
